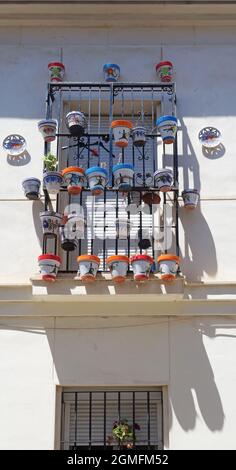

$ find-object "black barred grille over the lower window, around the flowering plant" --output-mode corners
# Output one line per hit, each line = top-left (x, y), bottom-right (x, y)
(61, 388), (163, 450)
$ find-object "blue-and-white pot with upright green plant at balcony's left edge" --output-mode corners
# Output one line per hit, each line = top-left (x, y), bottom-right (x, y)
(43, 153), (63, 194)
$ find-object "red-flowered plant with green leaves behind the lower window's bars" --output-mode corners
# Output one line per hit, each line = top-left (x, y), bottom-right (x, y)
(107, 418), (140, 449)
